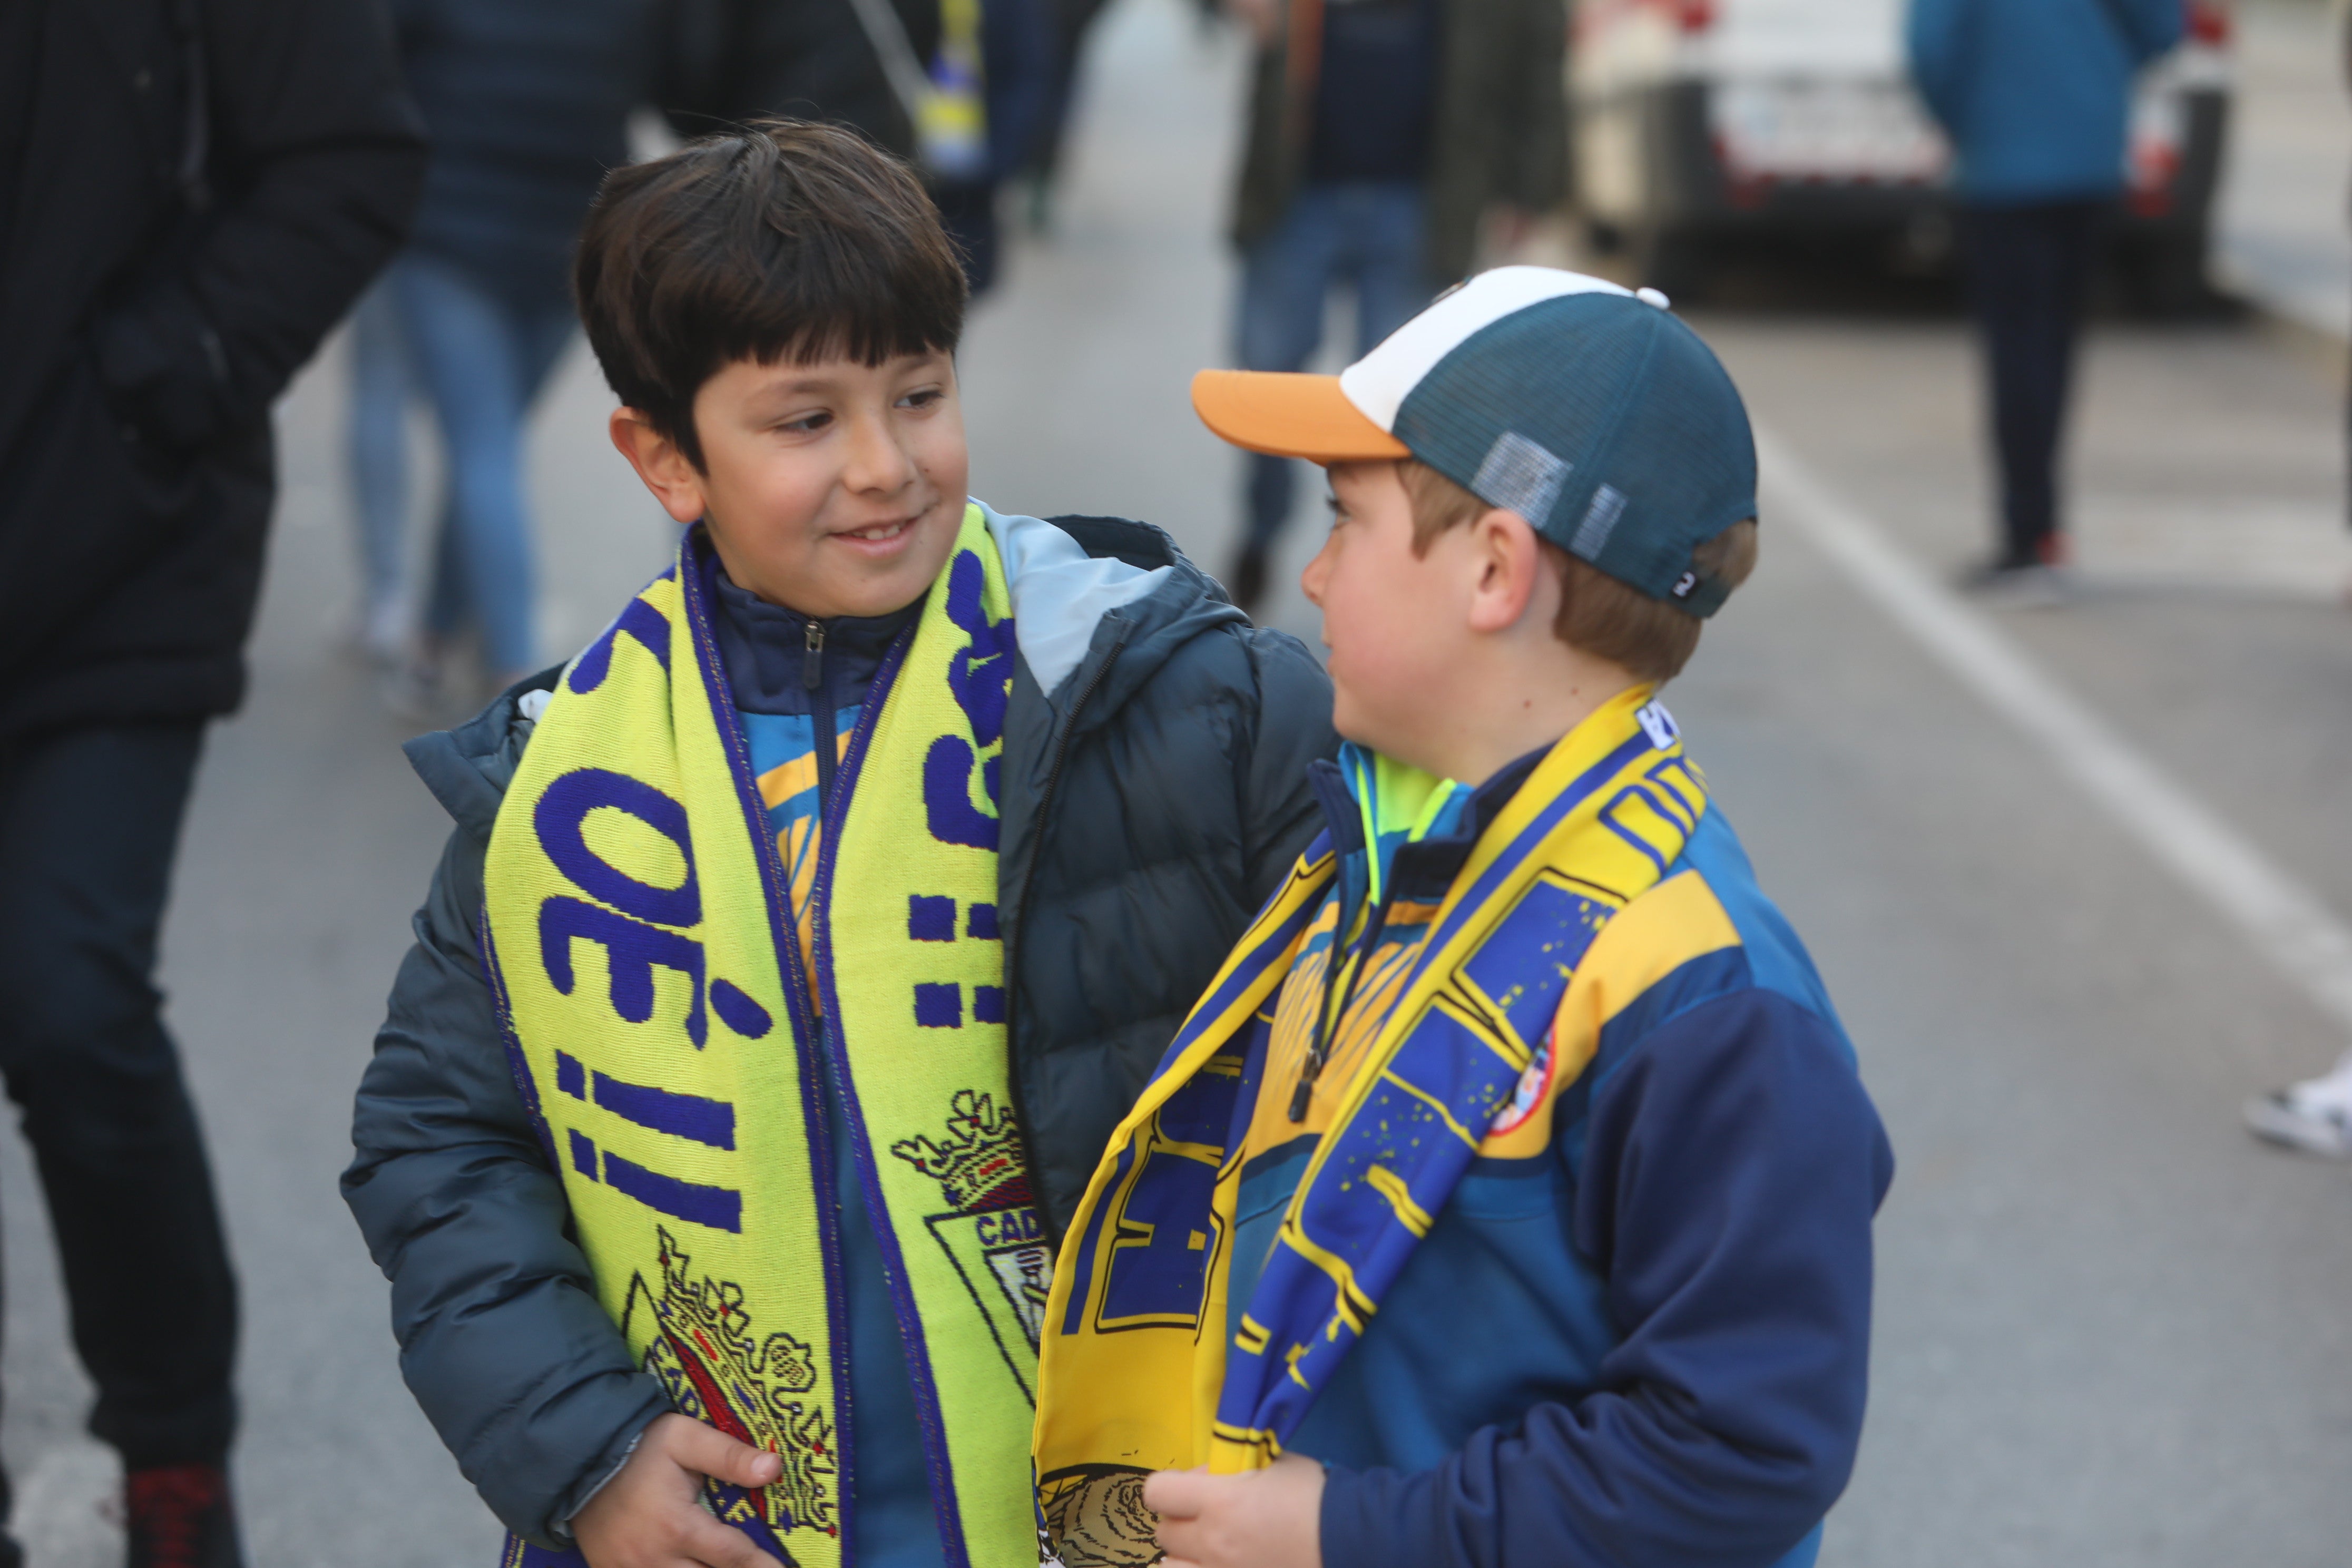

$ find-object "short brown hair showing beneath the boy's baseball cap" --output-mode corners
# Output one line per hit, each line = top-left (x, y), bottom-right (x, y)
(1397, 458), (1757, 682)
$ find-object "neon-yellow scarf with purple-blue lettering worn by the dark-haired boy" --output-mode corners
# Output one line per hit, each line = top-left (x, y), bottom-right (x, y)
(485, 508), (1049, 1568)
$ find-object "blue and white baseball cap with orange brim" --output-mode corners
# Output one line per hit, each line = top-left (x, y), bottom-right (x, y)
(1192, 266), (1757, 616)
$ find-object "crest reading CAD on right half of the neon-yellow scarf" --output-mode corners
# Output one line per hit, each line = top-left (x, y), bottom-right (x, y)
(889, 1089), (1054, 1406)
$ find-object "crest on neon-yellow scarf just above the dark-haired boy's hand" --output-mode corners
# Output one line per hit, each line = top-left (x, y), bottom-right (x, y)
(621, 1230), (842, 1535)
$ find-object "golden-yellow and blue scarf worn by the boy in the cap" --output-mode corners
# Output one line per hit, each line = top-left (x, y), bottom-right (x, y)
(1035, 689), (1708, 1568)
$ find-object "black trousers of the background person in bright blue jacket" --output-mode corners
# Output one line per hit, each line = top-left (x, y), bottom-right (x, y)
(1959, 202), (2108, 566)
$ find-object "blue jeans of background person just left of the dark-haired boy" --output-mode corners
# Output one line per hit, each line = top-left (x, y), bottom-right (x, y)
(390, 251), (574, 677)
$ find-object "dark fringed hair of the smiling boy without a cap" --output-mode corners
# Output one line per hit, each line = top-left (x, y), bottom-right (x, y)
(572, 120), (967, 468)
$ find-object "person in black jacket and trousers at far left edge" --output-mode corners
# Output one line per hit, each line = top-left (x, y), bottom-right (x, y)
(0, 0), (424, 1568)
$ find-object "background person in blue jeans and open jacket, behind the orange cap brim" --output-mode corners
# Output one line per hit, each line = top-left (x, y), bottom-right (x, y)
(1226, 0), (1566, 611)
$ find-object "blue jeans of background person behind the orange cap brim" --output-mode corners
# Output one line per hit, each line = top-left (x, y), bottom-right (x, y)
(1235, 183), (1435, 550)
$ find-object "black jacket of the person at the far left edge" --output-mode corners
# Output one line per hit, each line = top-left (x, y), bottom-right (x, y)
(0, 0), (426, 740)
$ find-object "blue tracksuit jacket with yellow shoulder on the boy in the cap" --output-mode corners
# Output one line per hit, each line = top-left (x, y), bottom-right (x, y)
(1228, 752), (1894, 1568)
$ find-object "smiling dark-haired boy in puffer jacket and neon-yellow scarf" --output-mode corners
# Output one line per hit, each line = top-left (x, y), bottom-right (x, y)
(344, 122), (1334, 1568)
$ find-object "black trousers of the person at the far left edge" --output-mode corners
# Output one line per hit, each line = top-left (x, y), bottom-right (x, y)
(0, 722), (238, 1500)
